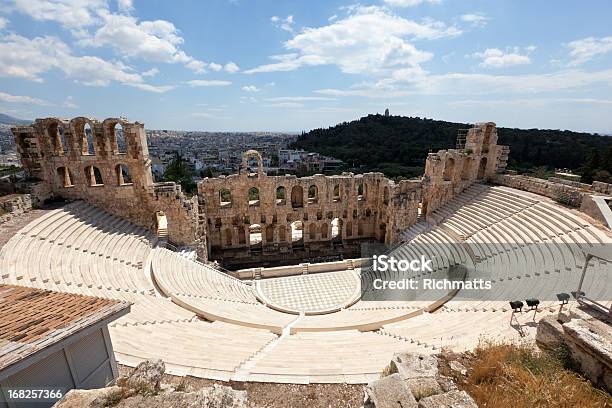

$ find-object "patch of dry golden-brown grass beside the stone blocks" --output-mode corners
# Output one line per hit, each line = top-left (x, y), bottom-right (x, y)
(444, 342), (612, 408)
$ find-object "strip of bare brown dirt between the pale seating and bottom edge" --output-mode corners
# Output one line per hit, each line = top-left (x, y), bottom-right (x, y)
(119, 365), (364, 408)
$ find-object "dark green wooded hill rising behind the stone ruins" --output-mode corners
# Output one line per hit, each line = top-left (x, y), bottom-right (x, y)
(292, 115), (612, 181)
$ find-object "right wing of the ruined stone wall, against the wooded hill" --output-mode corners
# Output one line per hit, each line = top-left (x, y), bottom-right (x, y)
(421, 122), (509, 217)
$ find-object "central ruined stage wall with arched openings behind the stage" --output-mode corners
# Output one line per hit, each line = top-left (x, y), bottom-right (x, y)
(198, 151), (420, 266)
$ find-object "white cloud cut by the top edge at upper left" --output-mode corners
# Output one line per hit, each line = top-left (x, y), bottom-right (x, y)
(12, 0), (108, 29)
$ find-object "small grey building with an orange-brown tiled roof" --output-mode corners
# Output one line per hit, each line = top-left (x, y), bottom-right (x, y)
(0, 285), (131, 408)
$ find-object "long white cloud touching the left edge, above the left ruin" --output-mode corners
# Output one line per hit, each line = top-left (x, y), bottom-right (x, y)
(0, 34), (168, 91)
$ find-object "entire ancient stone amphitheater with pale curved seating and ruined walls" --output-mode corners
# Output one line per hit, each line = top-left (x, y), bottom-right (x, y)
(0, 118), (612, 383)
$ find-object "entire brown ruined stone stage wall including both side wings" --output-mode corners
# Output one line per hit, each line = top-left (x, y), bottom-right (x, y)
(12, 117), (508, 267)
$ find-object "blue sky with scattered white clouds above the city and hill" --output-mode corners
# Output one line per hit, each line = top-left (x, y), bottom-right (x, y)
(0, 0), (612, 132)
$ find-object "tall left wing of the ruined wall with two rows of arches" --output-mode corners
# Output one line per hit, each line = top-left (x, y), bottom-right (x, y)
(12, 117), (201, 245)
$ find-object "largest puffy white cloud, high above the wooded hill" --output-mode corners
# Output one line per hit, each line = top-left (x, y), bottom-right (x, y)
(245, 6), (461, 74)
